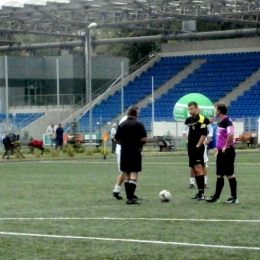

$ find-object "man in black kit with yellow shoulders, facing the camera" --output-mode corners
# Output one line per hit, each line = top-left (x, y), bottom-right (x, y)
(184, 101), (210, 201)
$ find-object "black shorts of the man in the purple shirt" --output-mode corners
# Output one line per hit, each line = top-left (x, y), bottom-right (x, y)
(216, 146), (236, 176)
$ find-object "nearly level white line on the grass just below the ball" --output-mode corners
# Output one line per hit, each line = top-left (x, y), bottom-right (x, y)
(0, 217), (260, 223)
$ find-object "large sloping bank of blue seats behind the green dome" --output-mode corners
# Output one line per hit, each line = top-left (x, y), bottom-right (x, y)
(70, 52), (260, 131)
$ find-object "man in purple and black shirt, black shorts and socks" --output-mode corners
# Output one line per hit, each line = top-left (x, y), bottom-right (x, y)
(206, 103), (239, 204)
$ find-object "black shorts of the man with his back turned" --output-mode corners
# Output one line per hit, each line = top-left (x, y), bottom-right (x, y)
(120, 149), (142, 172)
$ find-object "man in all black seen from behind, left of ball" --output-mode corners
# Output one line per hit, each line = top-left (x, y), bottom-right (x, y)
(115, 106), (147, 205)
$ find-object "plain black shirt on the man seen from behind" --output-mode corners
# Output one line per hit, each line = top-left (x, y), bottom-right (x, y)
(115, 117), (147, 151)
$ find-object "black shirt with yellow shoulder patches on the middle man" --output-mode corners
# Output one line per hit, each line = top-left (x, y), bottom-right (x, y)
(184, 114), (210, 147)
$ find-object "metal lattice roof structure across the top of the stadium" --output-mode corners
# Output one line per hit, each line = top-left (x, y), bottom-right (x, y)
(0, 0), (260, 37)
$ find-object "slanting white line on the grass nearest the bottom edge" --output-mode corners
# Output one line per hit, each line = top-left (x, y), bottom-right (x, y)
(0, 232), (260, 250)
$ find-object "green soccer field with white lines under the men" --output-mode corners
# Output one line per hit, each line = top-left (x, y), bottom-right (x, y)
(0, 152), (260, 260)
